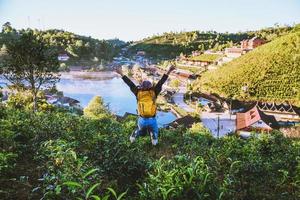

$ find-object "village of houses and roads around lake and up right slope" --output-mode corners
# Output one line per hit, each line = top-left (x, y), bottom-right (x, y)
(2, 29), (300, 137)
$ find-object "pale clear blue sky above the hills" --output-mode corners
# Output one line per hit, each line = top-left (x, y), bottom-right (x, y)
(0, 0), (300, 41)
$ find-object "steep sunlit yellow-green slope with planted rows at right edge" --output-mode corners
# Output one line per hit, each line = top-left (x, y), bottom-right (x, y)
(194, 28), (300, 105)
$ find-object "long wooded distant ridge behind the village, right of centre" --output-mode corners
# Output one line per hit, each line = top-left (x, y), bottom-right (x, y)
(129, 26), (292, 59)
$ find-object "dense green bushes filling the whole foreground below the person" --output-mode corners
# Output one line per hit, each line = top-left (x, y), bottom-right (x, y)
(0, 104), (300, 199)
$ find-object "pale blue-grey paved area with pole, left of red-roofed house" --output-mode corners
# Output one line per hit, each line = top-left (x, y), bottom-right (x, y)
(201, 112), (236, 137)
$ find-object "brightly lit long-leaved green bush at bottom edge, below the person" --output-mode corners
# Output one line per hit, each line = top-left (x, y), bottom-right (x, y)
(138, 156), (213, 199)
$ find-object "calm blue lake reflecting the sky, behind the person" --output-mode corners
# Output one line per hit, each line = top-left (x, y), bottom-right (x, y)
(0, 72), (176, 127)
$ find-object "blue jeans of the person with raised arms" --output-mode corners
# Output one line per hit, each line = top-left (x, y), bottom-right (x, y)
(136, 117), (158, 139)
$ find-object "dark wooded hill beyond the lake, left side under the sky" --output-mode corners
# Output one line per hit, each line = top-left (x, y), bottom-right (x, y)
(0, 22), (120, 65)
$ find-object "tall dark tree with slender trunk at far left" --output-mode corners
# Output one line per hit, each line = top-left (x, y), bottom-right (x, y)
(0, 29), (59, 111)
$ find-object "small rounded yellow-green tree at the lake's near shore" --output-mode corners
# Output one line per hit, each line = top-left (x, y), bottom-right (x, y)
(83, 96), (108, 118)
